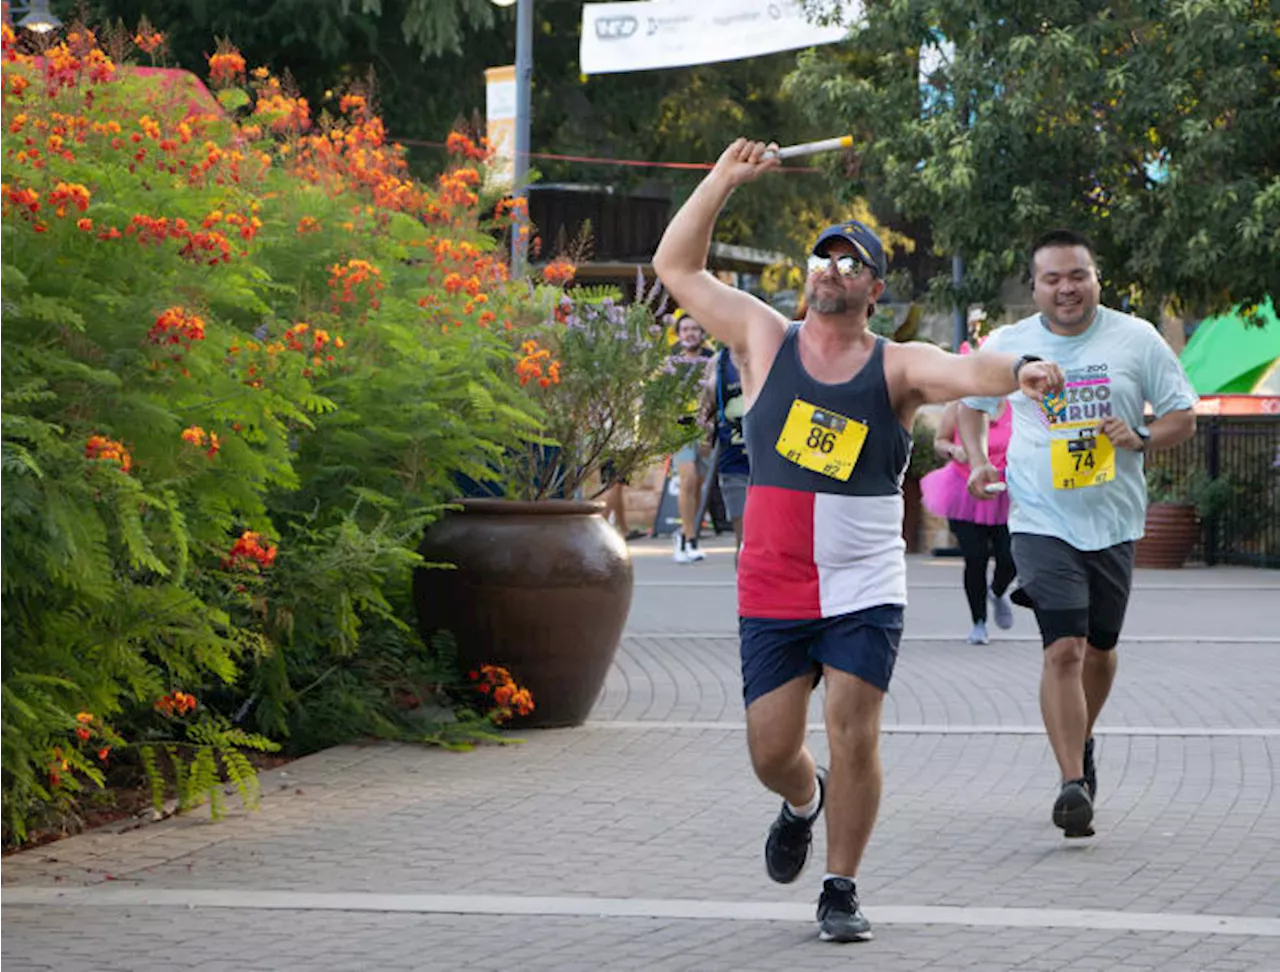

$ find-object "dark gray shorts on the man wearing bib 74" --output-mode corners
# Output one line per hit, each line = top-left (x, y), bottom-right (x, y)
(1012, 533), (1134, 651)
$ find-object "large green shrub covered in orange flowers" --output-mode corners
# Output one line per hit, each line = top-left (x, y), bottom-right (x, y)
(0, 23), (542, 844)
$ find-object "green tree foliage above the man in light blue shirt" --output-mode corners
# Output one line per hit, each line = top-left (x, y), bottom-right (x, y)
(788, 0), (1280, 315)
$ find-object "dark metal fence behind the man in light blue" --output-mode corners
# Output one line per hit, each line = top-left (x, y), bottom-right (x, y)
(1147, 415), (1280, 567)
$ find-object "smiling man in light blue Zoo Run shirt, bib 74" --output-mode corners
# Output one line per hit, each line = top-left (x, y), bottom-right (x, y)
(959, 229), (1196, 838)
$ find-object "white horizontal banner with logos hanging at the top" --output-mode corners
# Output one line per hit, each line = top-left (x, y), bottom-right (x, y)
(579, 0), (863, 74)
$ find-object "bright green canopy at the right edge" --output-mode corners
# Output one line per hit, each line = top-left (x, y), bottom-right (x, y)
(1181, 297), (1280, 394)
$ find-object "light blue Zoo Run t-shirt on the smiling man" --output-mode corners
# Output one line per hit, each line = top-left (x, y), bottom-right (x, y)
(965, 307), (1197, 551)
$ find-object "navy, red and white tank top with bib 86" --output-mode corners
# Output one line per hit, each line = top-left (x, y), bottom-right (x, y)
(737, 324), (911, 619)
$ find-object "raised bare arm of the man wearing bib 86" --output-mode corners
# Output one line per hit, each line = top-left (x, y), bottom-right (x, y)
(653, 138), (785, 357)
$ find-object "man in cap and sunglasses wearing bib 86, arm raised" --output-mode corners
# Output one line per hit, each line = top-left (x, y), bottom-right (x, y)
(653, 138), (1062, 941)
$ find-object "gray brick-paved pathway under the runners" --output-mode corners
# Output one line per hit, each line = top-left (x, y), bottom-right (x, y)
(0, 542), (1280, 972)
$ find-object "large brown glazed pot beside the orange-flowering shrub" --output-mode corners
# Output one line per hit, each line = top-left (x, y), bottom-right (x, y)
(413, 499), (634, 729)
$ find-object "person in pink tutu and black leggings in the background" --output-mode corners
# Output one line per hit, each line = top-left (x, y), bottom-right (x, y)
(920, 386), (1018, 644)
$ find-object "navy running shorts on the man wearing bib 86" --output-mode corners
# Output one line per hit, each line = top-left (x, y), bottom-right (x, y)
(737, 604), (902, 706)
